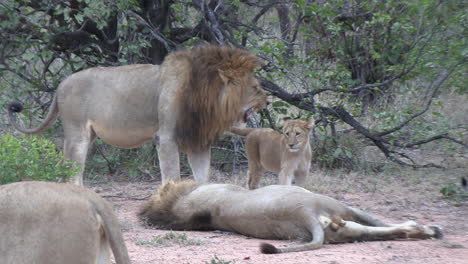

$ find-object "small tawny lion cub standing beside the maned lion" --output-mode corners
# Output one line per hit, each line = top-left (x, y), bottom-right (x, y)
(231, 118), (314, 189)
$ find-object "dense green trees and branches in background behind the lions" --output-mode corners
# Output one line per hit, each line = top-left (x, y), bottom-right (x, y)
(0, 0), (468, 179)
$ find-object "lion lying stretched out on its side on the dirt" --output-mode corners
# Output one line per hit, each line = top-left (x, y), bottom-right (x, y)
(139, 181), (442, 254)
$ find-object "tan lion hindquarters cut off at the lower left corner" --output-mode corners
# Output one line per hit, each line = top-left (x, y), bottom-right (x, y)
(0, 182), (130, 264)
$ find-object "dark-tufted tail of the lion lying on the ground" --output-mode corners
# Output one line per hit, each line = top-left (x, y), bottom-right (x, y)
(260, 219), (330, 254)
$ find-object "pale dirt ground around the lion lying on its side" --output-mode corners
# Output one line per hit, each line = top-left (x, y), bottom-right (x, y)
(88, 170), (468, 264)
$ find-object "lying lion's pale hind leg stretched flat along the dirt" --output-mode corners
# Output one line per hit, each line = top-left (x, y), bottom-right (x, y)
(326, 218), (442, 243)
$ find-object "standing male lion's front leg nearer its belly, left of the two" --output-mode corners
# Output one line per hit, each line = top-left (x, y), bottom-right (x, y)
(156, 138), (180, 182)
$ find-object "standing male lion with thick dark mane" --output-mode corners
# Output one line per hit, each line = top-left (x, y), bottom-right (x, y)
(9, 45), (266, 185)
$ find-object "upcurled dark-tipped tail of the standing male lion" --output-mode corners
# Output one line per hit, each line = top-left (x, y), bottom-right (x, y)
(8, 95), (58, 134)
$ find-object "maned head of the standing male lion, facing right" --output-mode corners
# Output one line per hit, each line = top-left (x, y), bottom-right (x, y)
(174, 45), (266, 152)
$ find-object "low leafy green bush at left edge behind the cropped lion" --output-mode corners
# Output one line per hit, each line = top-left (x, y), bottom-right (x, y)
(0, 134), (78, 184)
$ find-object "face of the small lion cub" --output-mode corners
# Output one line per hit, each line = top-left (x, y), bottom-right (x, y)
(283, 118), (314, 152)
